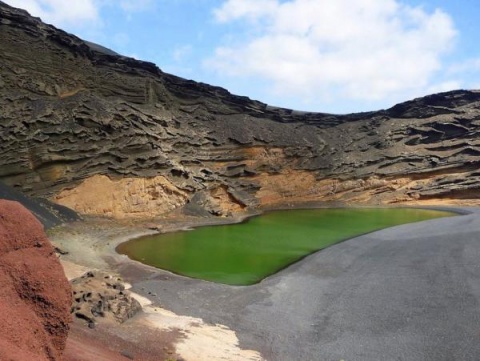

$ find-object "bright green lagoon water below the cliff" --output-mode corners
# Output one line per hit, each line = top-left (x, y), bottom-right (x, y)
(117, 208), (452, 285)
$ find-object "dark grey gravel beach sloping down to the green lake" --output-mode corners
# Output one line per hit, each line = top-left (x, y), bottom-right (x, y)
(128, 208), (480, 361)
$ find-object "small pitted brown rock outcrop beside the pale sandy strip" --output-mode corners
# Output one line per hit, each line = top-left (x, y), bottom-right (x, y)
(71, 271), (142, 328)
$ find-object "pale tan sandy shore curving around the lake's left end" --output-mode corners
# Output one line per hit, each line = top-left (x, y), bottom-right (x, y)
(49, 217), (264, 361)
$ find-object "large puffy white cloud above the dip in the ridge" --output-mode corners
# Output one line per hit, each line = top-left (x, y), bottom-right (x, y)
(205, 0), (456, 108)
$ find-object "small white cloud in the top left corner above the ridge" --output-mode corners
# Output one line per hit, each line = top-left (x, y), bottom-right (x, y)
(6, 0), (99, 26)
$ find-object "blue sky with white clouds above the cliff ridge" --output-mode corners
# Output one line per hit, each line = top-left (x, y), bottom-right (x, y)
(3, 0), (480, 113)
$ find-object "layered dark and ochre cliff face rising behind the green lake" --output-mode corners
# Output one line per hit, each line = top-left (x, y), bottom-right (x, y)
(0, 2), (480, 217)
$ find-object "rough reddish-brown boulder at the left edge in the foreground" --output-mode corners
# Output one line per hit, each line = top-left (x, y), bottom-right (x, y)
(0, 200), (72, 361)
